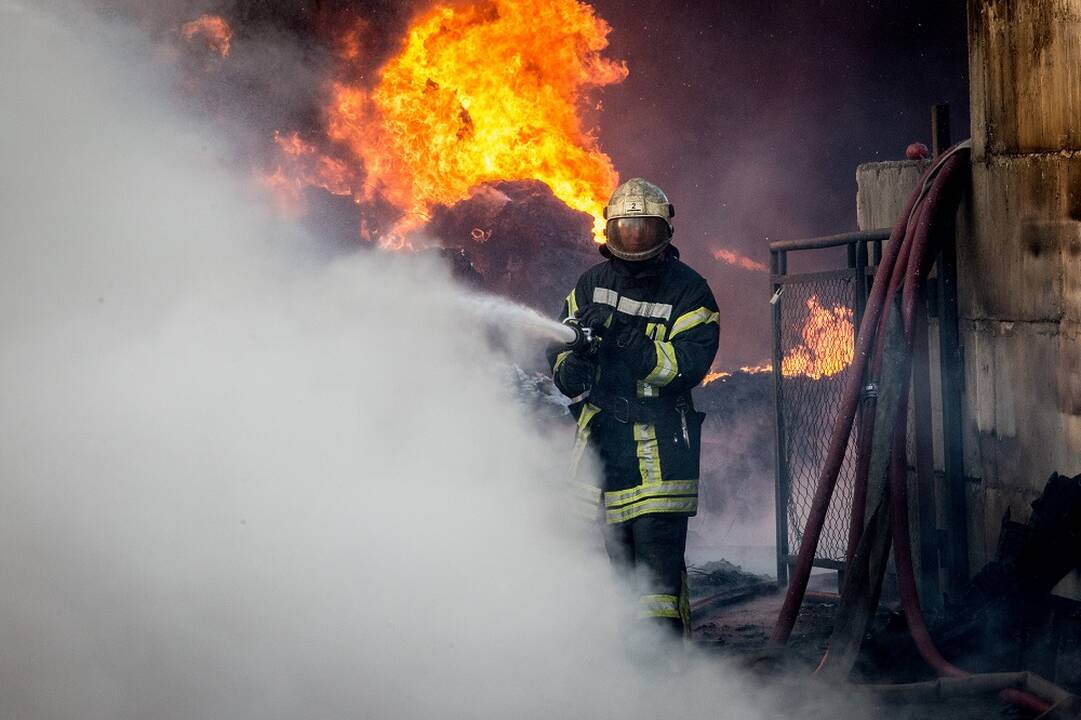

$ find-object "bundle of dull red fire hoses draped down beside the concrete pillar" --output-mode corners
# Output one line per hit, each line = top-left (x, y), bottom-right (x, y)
(771, 143), (1065, 714)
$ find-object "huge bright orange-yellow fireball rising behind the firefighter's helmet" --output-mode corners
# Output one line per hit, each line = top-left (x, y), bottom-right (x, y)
(271, 0), (627, 245)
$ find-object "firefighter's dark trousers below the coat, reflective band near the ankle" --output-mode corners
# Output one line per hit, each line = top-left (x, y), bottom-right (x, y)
(604, 515), (691, 637)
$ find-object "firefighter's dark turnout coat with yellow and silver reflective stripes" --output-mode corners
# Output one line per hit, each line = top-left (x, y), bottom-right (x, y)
(549, 246), (719, 523)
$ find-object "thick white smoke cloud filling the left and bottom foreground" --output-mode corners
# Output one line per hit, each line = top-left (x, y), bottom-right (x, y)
(0, 5), (851, 720)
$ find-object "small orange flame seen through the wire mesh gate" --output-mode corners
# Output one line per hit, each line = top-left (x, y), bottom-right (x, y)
(780, 295), (855, 379)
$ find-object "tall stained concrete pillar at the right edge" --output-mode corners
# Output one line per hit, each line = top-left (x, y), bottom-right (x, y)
(958, 0), (1081, 572)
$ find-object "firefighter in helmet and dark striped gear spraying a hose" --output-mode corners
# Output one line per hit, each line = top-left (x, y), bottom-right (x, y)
(549, 177), (719, 637)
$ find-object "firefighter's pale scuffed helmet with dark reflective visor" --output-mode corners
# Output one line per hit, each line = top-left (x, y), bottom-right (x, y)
(604, 177), (676, 261)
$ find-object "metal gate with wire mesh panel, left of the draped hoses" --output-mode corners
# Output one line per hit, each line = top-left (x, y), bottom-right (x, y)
(770, 230), (890, 585)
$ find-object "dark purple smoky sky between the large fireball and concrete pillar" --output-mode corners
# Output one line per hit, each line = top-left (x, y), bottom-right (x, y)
(592, 0), (969, 366)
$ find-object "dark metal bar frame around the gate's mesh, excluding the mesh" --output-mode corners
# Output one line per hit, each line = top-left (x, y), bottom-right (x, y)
(770, 229), (890, 585)
